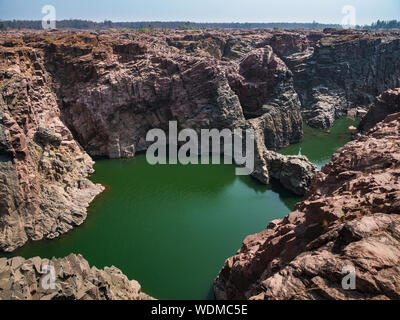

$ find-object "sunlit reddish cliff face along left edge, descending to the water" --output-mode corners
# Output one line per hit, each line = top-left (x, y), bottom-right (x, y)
(0, 38), (103, 251)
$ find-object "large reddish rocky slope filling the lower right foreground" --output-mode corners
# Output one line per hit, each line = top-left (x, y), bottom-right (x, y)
(214, 113), (400, 299)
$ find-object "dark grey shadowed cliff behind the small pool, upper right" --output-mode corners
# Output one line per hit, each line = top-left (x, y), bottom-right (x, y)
(284, 29), (400, 128)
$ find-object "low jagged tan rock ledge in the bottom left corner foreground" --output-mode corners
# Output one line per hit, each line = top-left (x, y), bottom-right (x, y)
(0, 254), (152, 300)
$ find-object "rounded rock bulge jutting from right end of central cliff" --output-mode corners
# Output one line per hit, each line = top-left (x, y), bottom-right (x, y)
(228, 45), (303, 150)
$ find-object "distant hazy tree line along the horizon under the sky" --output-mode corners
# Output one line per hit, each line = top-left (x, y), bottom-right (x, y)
(0, 19), (400, 30)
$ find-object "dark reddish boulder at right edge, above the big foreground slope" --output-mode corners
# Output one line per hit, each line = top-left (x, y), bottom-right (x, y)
(358, 88), (400, 132)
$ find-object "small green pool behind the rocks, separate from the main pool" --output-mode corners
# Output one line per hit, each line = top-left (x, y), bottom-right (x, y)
(279, 117), (360, 169)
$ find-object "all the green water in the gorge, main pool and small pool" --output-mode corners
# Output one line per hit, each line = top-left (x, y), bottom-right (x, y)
(1, 119), (360, 299)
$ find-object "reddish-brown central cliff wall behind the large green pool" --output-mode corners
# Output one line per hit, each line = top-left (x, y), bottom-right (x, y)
(35, 32), (302, 158)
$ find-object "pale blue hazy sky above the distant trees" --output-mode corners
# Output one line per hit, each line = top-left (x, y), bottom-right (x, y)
(0, 0), (400, 24)
